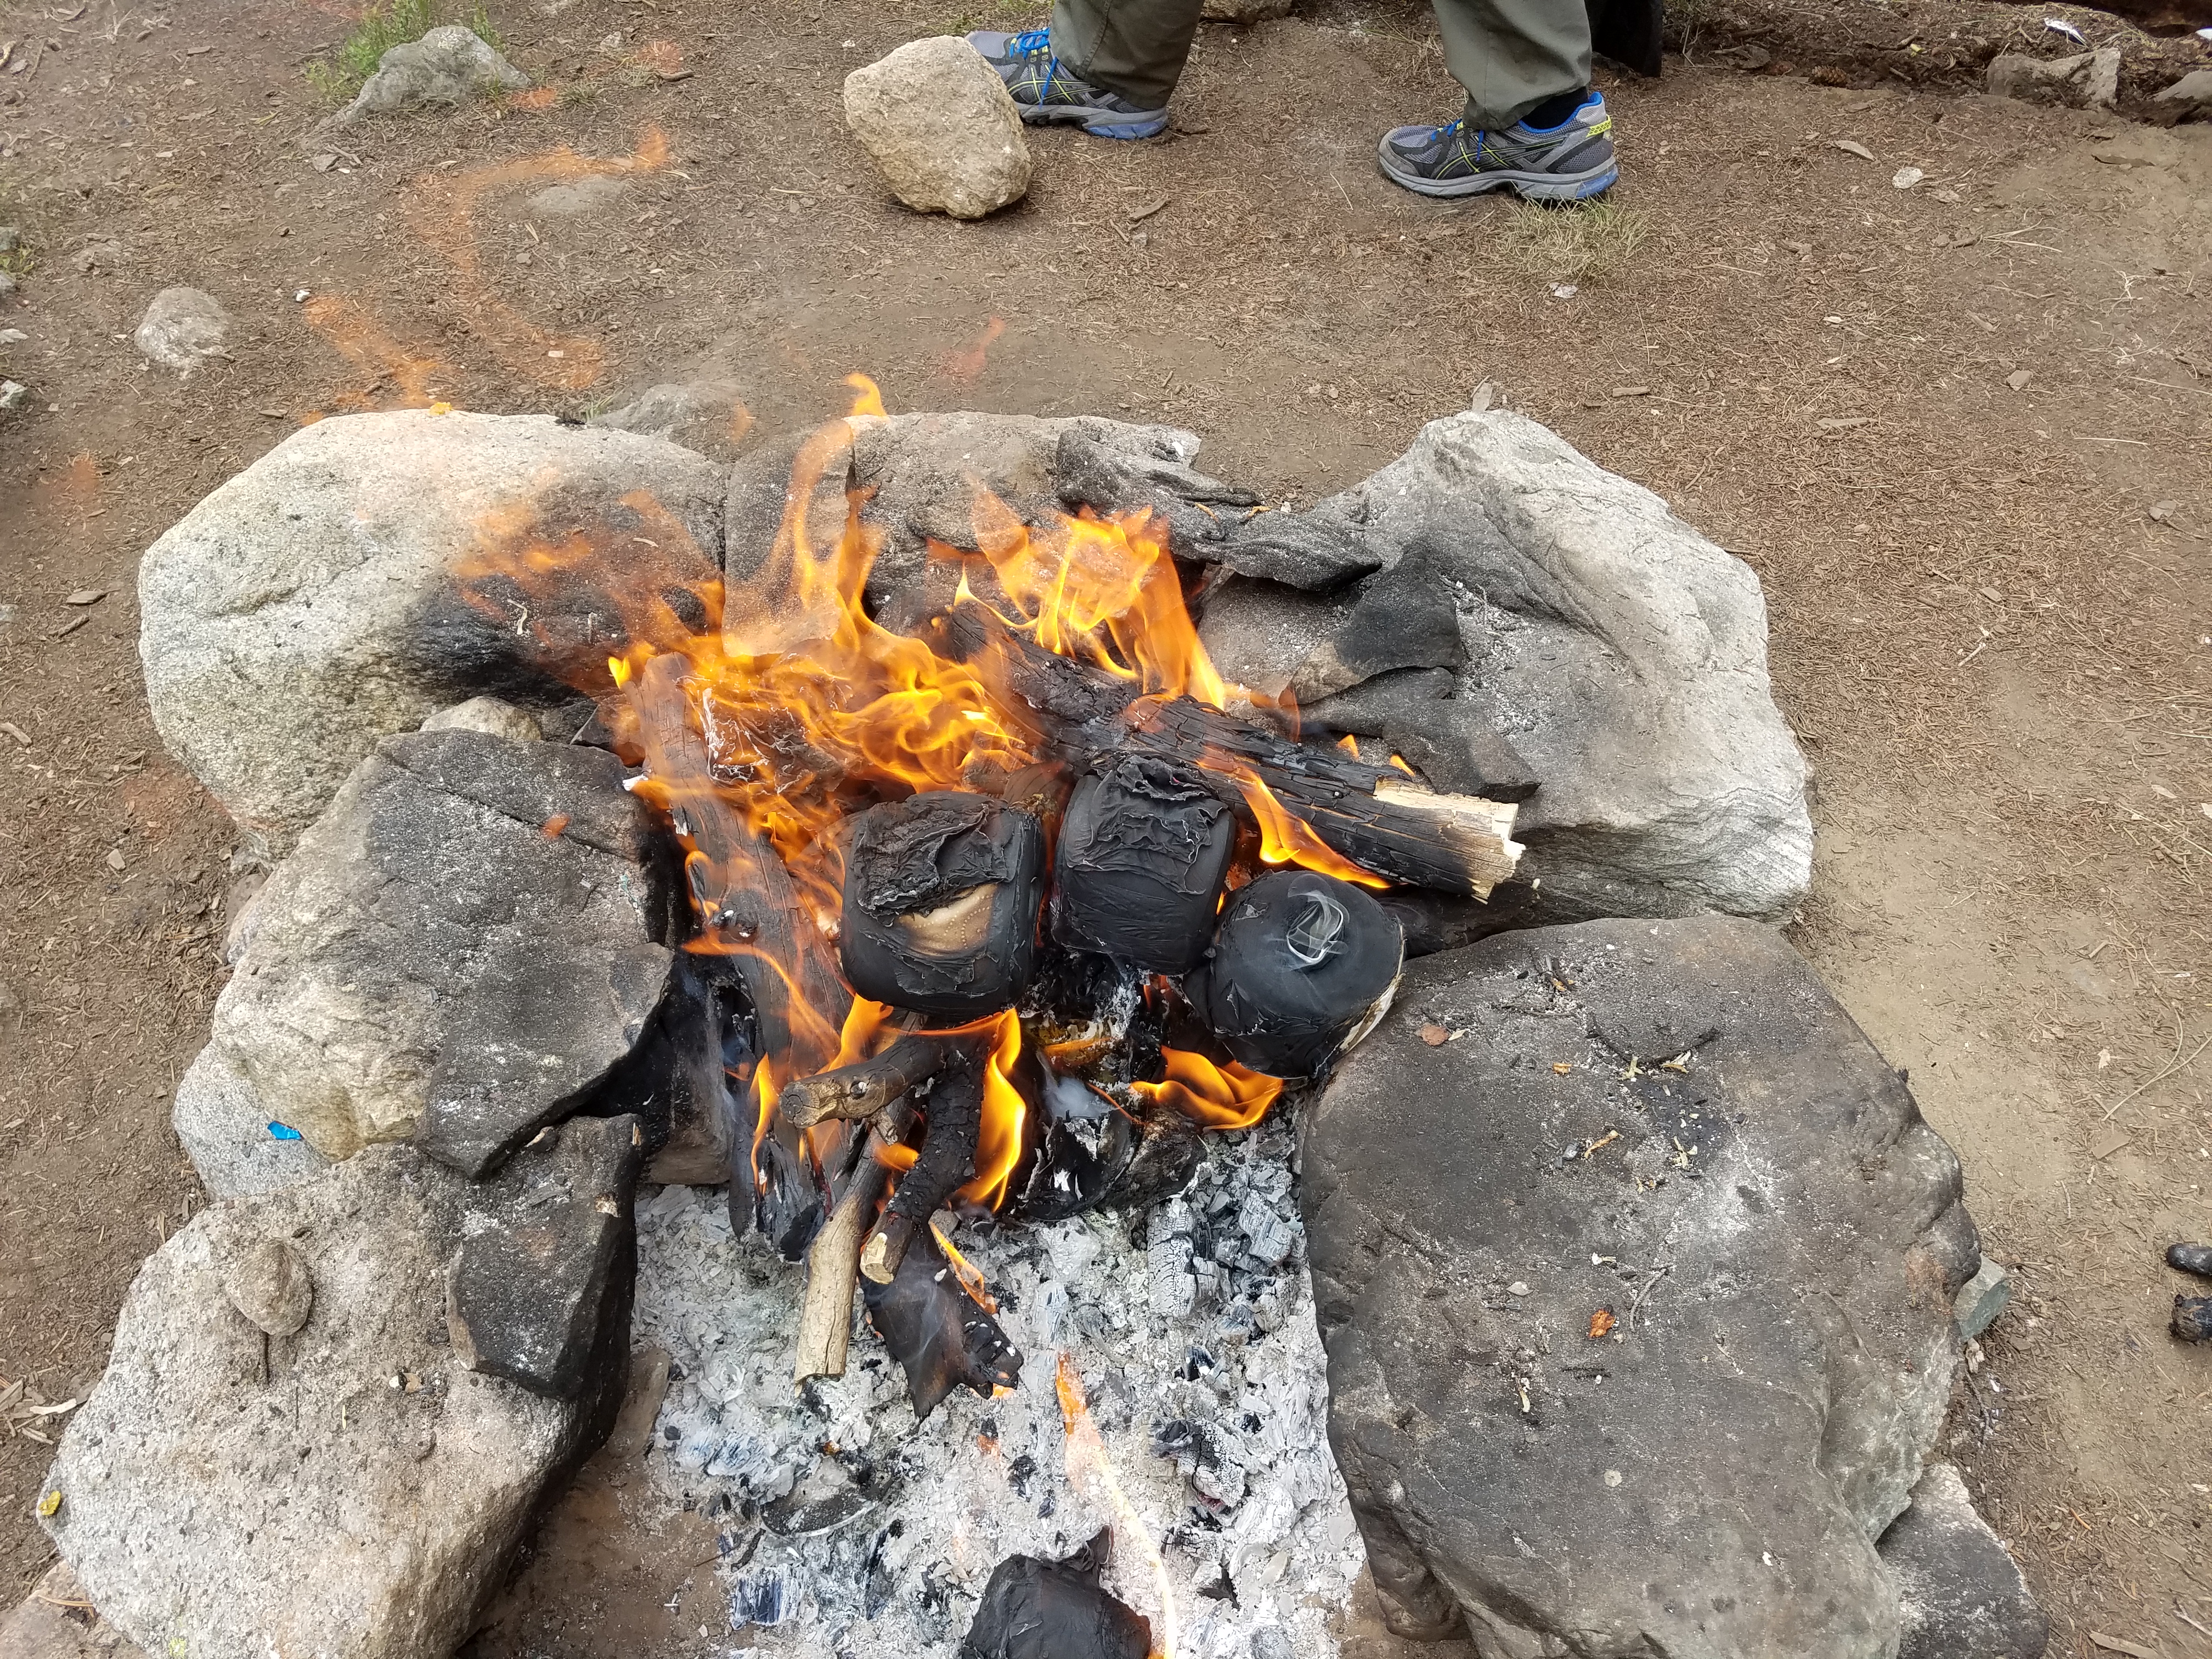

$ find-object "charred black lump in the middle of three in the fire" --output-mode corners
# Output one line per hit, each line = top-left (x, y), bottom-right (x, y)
(1053, 757), (1237, 973)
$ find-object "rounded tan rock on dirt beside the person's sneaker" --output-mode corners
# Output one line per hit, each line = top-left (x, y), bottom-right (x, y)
(845, 36), (1031, 219)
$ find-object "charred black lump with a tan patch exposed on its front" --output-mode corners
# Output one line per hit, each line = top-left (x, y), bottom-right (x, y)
(838, 789), (1044, 1020)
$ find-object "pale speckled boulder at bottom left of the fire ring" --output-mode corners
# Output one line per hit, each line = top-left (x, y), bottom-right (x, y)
(47, 1119), (637, 1659)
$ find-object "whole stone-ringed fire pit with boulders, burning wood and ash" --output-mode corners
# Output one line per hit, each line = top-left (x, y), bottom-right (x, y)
(13, 393), (2033, 1659)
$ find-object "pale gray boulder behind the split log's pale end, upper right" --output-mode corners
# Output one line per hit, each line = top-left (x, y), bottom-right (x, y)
(1201, 409), (1812, 931)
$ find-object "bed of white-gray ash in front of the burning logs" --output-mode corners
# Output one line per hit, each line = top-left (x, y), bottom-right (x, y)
(635, 1108), (1365, 1659)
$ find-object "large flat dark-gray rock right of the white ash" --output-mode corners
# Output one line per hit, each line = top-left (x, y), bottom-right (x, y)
(1301, 918), (1978, 1659)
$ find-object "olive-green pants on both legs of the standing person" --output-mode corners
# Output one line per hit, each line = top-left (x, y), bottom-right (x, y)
(1053, 0), (1590, 133)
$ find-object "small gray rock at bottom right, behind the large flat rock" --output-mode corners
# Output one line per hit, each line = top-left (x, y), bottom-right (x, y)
(1882, 1462), (2051, 1659)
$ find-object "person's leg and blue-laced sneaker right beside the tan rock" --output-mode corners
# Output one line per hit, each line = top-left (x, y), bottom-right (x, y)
(969, 0), (1203, 137)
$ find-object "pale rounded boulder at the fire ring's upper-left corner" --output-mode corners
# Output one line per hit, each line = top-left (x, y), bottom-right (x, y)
(139, 409), (723, 856)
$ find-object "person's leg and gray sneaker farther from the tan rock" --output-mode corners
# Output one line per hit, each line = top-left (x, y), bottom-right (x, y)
(1376, 0), (1619, 201)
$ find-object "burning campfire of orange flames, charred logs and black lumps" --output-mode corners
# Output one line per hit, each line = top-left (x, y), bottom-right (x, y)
(451, 387), (1520, 1415)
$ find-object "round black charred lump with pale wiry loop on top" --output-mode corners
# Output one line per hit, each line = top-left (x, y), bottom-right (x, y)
(1190, 870), (1404, 1077)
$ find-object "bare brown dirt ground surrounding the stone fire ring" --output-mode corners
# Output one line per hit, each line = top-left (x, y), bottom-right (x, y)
(0, 0), (2212, 1659)
